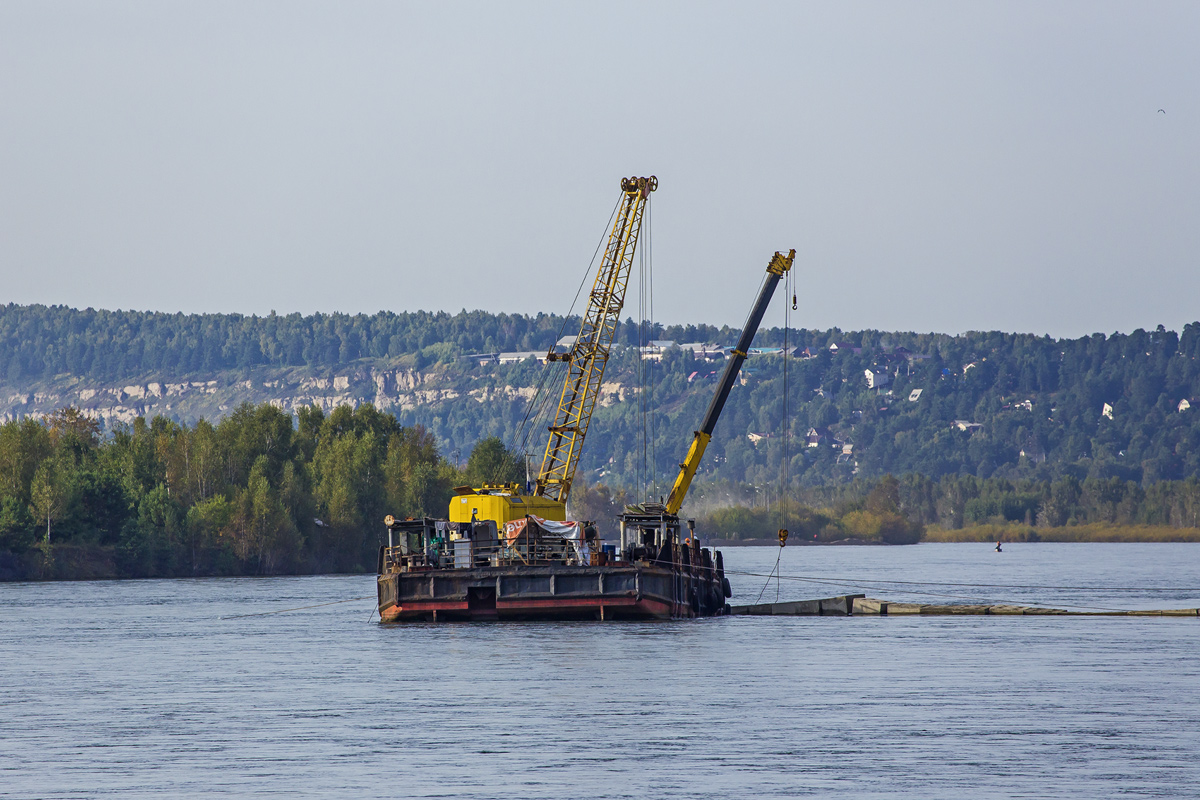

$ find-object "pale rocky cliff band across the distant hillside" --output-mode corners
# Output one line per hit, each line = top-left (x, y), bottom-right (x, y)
(0, 365), (631, 427)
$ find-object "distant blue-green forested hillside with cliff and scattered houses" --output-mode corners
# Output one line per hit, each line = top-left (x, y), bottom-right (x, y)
(0, 305), (1200, 493)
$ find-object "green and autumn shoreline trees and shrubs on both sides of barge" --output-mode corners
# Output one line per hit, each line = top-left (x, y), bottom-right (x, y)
(7, 403), (1200, 581)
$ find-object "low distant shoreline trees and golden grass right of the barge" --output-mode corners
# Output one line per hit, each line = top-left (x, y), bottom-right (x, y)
(572, 473), (1200, 545)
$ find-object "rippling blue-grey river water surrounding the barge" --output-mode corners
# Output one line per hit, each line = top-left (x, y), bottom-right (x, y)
(0, 543), (1200, 800)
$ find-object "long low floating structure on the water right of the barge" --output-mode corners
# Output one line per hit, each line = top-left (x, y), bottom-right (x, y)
(730, 595), (1200, 616)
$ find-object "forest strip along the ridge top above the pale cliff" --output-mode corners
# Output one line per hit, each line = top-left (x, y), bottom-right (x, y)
(0, 303), (727, 384)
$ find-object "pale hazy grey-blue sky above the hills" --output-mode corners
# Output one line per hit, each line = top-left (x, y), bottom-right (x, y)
(0, 0), (1200, 337)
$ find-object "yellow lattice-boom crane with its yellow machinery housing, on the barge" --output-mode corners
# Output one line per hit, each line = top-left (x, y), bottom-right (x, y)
(450, 175), (659, 524)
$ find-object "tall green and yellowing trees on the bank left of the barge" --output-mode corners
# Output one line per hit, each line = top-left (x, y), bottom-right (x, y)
(0, 404), (521, 578)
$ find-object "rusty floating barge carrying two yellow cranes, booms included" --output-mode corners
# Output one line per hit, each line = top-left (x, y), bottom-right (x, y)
(377, 176), (796, 622)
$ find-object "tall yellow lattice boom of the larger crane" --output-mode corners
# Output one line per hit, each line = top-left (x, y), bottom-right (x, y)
(534, 175), (659, 503)
